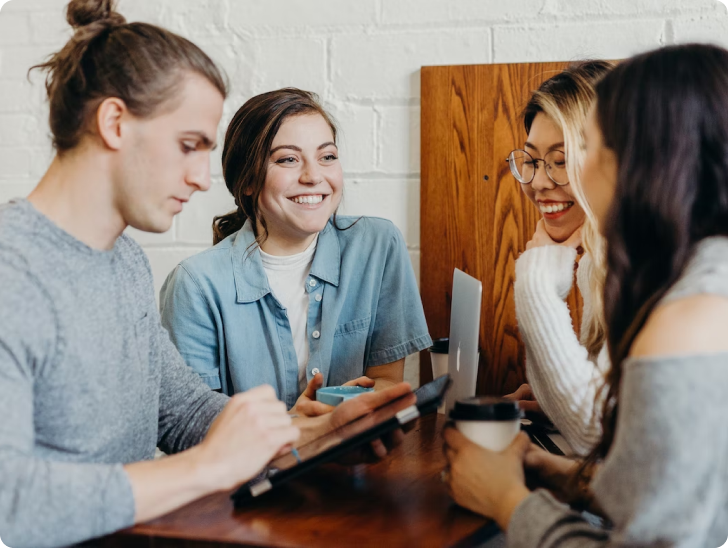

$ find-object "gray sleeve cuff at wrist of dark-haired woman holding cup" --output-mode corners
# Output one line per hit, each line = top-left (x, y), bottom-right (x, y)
(507, 489), (609, 548)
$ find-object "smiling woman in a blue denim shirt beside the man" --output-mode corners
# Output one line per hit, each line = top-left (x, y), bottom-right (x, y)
(160, 88), (431, 415)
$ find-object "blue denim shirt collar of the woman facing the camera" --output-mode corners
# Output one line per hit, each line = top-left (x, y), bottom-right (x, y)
(232, 220), (341, 303)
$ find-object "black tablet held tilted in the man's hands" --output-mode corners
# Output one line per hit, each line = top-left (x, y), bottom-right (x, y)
(232, 375), (452, 507)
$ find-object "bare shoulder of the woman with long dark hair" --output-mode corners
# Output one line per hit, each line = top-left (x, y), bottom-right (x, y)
(630, 293), (728, 357)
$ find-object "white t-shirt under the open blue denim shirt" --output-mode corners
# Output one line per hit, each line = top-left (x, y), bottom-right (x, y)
(259, 235), (318, 393)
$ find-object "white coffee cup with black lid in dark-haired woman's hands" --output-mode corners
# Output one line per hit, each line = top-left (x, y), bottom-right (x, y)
(450, 396), (523, 451)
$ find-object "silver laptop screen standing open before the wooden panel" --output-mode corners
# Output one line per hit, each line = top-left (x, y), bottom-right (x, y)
(446, 268), (483, 413)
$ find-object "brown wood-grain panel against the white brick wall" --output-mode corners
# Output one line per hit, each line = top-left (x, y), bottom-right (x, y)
(420, 63), (581, 395)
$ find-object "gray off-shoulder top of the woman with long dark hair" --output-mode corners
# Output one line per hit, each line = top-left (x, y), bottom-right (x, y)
(508, 237), (728, 548)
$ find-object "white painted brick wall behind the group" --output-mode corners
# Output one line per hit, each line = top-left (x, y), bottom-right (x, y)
(0, 0), (728, 381)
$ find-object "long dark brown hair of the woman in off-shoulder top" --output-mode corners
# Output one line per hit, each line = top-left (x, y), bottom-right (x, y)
(582, 44), (728, 475)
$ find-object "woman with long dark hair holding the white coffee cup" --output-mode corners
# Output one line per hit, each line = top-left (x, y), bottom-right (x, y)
(445, 45), (728, 547)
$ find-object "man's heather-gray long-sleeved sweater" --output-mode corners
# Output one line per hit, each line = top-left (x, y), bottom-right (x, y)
(0, 200), (227, 548)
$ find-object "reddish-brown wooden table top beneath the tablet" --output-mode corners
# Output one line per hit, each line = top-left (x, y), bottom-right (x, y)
(102, 415), (494, 548)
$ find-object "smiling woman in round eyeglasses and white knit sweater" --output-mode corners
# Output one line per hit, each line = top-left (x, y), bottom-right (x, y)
(507, 61), (612, 454)
